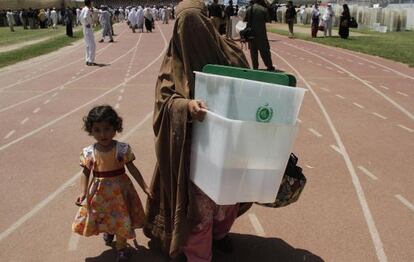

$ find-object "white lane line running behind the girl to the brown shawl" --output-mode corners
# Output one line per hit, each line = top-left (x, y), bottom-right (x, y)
(0, 112), (153, 241)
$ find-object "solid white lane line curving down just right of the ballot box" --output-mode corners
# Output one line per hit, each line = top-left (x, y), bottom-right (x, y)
(270, 50), (388, 262)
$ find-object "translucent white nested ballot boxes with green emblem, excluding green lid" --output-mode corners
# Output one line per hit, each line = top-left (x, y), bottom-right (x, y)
(190, 72), (305, 205)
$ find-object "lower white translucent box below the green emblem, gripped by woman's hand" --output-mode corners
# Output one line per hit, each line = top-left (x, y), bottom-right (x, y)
(190, 112), (298, 205)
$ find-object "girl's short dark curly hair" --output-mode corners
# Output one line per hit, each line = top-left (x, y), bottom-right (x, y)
(83, 105), (122, 134)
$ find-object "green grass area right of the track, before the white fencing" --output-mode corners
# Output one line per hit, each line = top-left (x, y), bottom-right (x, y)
(269, 25), (414, 67)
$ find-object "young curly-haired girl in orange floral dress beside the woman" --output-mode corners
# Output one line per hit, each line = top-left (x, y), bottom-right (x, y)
(72, 105), (152, 261)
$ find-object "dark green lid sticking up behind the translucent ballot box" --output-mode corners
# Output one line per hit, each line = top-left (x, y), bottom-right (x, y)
(203, 64), (296, 86)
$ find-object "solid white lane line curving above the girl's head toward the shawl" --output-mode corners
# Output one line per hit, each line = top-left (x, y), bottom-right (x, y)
(0, 24), (167, 151)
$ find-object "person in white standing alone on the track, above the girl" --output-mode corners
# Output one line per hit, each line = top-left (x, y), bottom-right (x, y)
(80, 0), (96, 66)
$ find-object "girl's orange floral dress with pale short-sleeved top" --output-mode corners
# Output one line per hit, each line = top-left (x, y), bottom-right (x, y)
(72, 142), (145, 239)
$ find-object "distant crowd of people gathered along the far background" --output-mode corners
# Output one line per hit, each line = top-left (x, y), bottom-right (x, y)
(0, 0), (351, 39)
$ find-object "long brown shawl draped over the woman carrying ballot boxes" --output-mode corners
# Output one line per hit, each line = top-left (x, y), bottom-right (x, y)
(144, 0), (248, 257)
